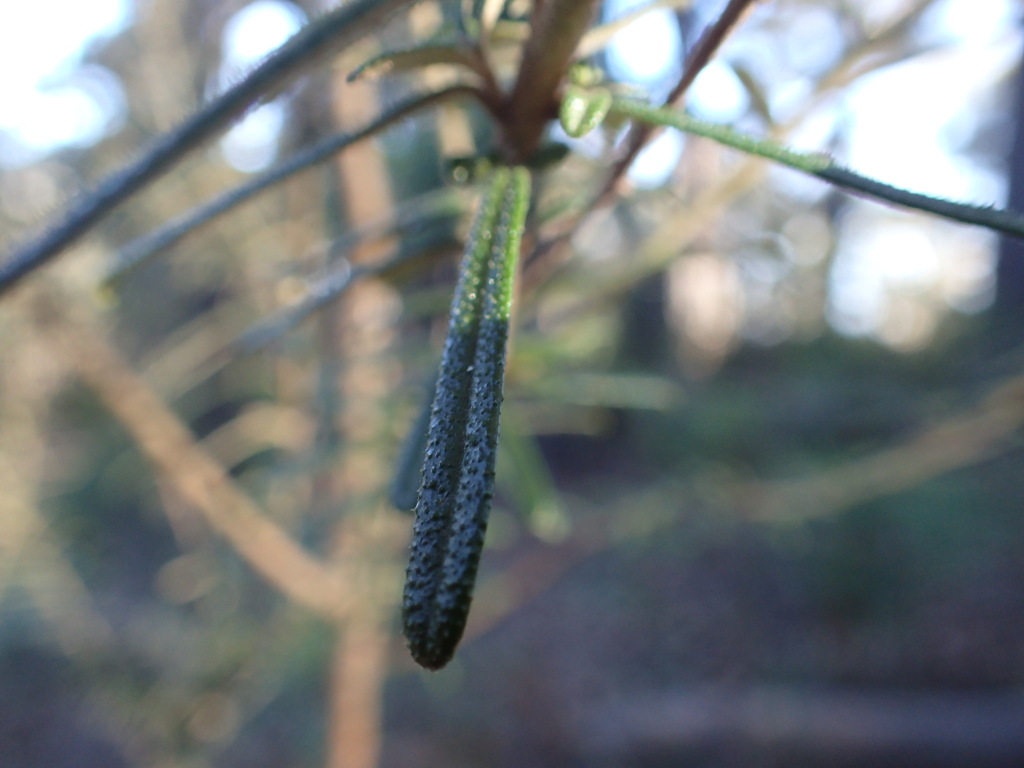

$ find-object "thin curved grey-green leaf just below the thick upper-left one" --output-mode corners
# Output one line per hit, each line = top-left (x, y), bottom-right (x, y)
(103, 85), (476, 287)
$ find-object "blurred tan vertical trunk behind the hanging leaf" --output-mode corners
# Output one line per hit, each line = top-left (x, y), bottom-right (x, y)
(314, 67), (401, 768)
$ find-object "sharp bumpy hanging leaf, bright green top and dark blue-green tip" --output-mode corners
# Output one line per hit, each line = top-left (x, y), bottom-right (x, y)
(402, 167), (529, 669)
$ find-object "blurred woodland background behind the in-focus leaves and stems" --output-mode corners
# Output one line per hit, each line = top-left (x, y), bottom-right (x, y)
(0, 0), (1024, 768)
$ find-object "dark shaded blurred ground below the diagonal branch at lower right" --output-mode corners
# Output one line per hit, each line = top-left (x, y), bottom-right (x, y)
(384, 434), (1024, 768)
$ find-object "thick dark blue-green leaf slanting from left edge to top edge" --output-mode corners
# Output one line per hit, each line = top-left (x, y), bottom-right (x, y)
(0, 0), (417, 294)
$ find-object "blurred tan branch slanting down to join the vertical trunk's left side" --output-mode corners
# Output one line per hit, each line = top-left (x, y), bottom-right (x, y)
(45, 296), (350, 620)
